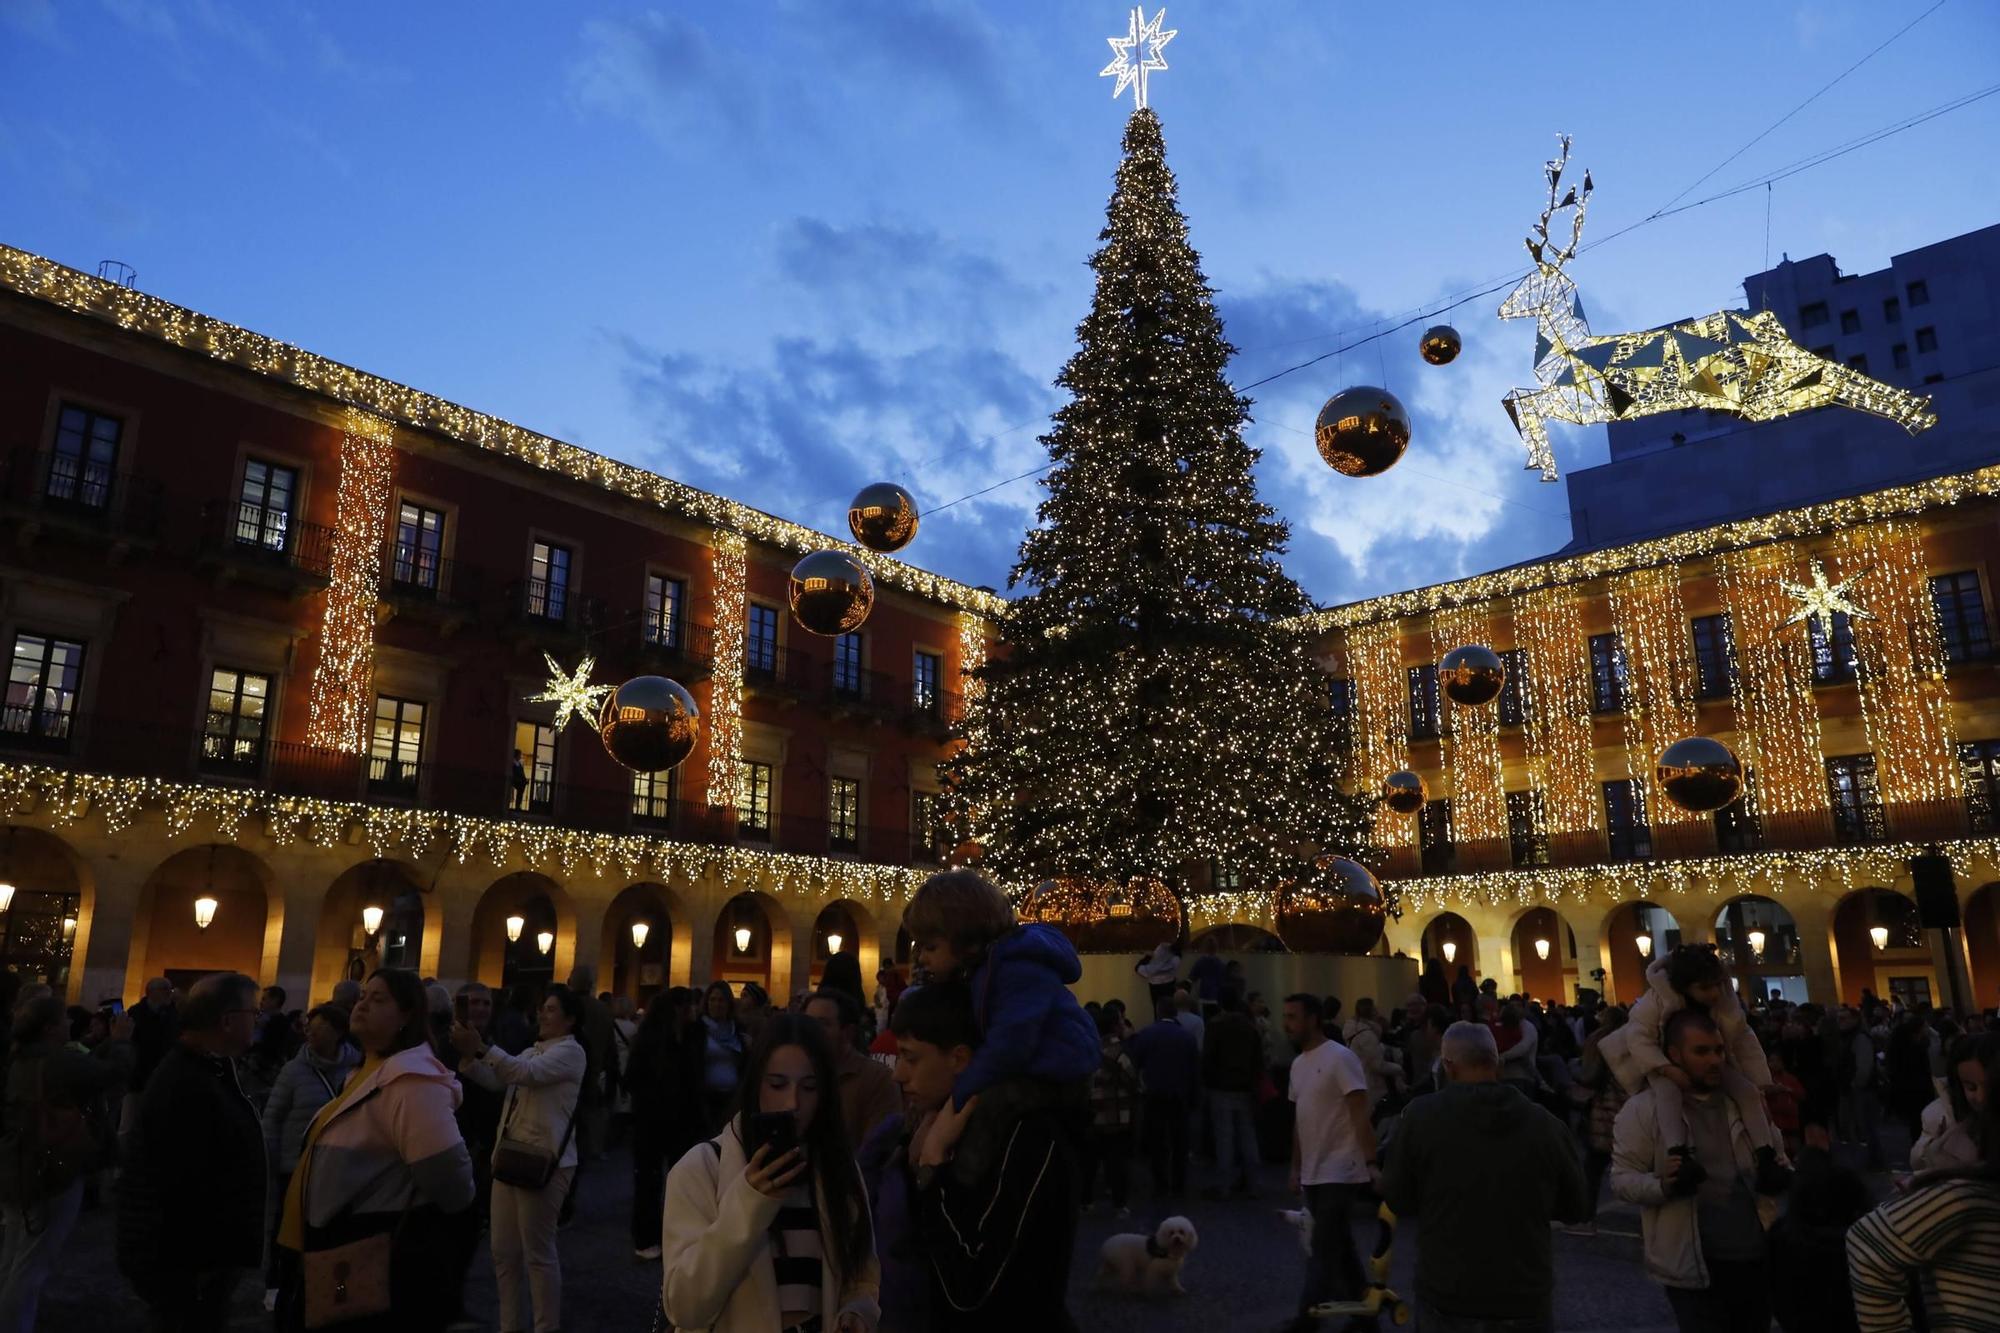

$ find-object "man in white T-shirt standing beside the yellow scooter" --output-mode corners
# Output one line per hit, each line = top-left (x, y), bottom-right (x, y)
(1284, 995), (1382, 1333)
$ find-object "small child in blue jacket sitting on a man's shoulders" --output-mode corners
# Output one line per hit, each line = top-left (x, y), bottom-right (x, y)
(902, 871), (1102, 1169)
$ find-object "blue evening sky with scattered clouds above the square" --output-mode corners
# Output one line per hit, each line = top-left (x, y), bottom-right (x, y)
(0, 0), (2000, 602)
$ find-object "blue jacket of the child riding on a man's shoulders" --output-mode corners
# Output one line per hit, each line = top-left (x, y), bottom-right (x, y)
(952, 925), (1102, 1107)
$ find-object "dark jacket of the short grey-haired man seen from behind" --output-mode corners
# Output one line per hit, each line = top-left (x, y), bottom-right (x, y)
(1382, 1083), (1590, 1319)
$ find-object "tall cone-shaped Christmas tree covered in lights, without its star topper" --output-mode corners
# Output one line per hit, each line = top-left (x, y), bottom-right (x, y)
(946, 108), (1366, 897)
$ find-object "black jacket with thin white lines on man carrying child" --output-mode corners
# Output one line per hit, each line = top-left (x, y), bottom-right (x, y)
(916, 1103), (1076, 1333)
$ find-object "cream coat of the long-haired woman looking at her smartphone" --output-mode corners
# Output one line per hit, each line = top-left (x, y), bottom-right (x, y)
(660, 1121), (882, 1333)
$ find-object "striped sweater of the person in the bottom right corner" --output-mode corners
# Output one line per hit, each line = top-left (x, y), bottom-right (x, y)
(1848, 1179), (2000, 1333)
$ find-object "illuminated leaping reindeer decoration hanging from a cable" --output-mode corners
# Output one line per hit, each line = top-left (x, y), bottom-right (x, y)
(1500, 134), (1938, 480)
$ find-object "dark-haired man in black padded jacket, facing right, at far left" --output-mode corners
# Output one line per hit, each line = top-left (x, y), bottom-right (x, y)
(118, 973), (266, 1333)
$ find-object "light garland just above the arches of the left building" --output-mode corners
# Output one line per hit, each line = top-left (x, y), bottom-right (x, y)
(0, 763), (930, 903)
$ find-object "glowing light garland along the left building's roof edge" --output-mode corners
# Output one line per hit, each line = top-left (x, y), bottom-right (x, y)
(0, 244), (1006, 616)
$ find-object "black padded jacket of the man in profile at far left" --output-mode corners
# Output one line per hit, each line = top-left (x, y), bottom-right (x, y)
(118, 1045), (264, 1297)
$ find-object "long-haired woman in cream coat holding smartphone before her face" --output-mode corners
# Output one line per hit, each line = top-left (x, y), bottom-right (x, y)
(660, 1013), (880, 1333)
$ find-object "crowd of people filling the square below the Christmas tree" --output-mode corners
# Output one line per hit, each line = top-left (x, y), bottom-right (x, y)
(0, 871), (2000, 1333)
